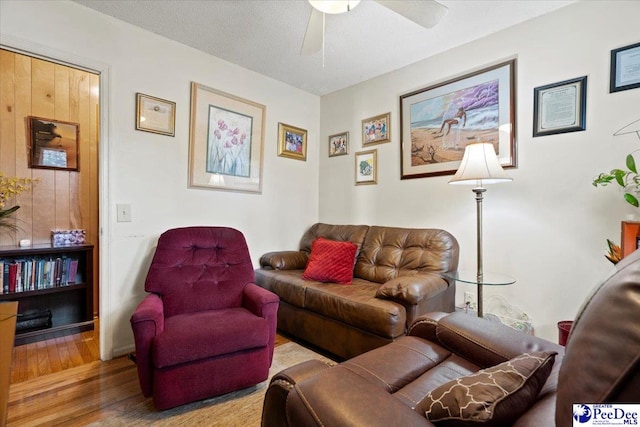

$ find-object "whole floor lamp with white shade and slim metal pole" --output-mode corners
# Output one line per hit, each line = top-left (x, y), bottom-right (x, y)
(449, 142), (512, 317)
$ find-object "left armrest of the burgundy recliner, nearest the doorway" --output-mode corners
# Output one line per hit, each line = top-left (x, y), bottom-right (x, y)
(130, 294), (164, 397)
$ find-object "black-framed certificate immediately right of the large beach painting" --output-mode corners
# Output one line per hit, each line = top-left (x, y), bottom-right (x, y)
(533, 76), (587, 137)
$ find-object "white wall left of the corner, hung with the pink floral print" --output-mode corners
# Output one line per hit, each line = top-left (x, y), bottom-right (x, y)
(0, 0), (324, 358)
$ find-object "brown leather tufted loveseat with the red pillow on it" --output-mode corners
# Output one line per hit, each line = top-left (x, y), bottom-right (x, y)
(256, 223), (458, 359)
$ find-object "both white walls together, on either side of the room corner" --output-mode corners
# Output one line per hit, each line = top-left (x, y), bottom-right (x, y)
(0, 0), (640, 358)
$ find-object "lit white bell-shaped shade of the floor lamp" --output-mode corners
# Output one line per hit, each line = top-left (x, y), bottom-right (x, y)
(449, 142), (512, 187)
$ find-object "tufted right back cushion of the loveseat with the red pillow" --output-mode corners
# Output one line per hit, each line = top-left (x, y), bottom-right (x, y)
(354, 226), (458, 283)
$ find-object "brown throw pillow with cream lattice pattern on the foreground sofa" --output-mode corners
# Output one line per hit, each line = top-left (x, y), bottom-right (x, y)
(420, 351), (557, 426)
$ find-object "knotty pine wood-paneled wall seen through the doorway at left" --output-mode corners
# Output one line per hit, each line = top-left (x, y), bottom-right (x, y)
(0, 49), (100, 312)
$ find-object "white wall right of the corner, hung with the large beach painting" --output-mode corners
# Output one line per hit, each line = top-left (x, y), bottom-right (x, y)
(320, 1), (640, 341)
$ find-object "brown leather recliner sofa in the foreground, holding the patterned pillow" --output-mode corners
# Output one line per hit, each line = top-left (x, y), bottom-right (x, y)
(262, 246), (640, 427)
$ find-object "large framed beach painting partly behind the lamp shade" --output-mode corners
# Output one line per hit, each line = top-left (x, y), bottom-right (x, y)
(400, 59), (516, 179)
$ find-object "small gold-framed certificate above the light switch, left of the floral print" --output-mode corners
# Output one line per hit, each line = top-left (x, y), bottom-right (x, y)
(136, 93), (176, 136)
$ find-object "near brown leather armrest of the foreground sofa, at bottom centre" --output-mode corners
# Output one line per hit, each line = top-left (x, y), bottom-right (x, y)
(262, 361), (433, 427)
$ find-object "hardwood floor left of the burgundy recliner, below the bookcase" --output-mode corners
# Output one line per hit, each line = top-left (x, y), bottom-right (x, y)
(7, 333), (290, 427)
